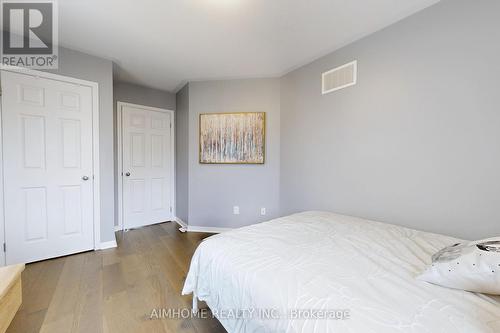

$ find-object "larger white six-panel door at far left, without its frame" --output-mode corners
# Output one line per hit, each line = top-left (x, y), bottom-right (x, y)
(2, 71), (94, 264)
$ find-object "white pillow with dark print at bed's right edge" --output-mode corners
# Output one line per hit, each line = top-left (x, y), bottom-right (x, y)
(417, 237), (500, 295)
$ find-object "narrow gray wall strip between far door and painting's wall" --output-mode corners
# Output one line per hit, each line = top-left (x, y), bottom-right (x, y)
(175, 84), (189, 223)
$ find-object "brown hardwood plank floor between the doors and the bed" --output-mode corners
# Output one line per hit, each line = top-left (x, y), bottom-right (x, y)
(7, 222), (226, 333)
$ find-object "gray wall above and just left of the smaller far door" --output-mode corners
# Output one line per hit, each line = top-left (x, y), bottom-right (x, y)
(113, 82), (175, 226)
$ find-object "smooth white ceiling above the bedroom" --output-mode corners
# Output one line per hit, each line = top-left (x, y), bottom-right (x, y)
(59, 0), (439, 91)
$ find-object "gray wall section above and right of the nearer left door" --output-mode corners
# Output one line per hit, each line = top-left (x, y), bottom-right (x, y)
(44, 48), (115, 242)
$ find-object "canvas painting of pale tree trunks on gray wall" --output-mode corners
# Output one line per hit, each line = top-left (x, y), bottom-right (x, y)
(200, 112), (266, 164)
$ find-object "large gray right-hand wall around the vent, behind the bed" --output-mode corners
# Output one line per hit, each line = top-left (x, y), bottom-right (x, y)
(280, 0), (500, 239)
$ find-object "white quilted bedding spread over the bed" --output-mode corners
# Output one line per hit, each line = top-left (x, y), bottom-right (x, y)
(182, 212), (500, 333)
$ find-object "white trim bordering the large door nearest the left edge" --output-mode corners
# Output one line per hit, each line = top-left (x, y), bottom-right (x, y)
(0, 65), (101, 264)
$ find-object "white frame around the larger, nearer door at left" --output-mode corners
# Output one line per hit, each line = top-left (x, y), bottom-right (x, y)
(0, 65), (101, 266)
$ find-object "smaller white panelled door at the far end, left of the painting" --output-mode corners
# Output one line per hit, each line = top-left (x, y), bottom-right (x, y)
(122, 105), (173, 229)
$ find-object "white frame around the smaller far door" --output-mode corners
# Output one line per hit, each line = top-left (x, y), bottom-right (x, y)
(115, 101), (175, 231)
